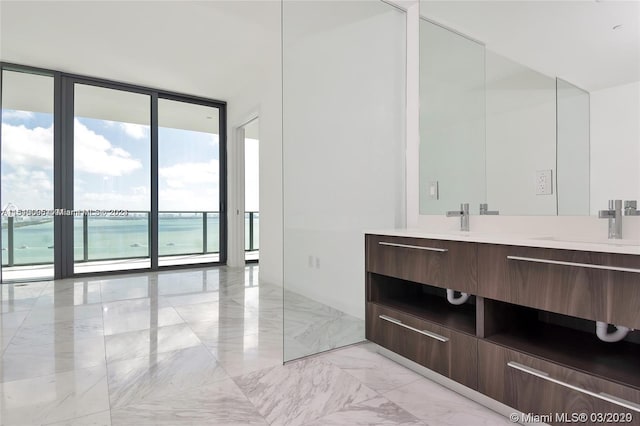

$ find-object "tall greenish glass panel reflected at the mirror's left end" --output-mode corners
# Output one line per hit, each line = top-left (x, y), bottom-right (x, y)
(420, 19), (486, 214)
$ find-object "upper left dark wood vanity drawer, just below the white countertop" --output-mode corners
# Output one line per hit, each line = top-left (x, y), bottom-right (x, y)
(366, 235), (477, 294)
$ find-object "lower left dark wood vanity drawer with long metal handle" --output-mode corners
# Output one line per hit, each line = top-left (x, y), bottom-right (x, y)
(366, 302), (478, 389)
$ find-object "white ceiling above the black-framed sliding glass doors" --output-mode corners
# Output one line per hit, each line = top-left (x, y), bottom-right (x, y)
(0, 0), (280, 101)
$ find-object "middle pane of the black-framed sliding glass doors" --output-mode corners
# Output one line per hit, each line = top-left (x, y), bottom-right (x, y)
(73, 84), (151, 273)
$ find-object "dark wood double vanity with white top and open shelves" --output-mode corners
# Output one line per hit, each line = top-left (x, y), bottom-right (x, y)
(365, 231), (640, 425)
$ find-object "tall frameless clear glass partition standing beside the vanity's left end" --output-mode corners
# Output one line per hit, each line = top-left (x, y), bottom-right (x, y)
(282, 1), (406, 360)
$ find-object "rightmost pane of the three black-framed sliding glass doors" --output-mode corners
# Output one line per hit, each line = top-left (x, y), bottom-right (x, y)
(158, 99), (220, 266)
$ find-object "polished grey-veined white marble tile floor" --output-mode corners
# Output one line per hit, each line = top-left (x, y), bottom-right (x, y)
(0, 265), (510, 426)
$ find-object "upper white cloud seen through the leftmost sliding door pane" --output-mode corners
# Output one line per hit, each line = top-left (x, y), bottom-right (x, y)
(2, 123), (53, 168)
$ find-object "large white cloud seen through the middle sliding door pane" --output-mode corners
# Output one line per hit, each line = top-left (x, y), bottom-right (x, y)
(74, 119), (142, 176)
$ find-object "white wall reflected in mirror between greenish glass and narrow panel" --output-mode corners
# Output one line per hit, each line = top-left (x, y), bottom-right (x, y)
(485, 49), (556, 215)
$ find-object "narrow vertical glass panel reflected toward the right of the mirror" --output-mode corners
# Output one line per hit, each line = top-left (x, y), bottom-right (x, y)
(556, 78), (590, 216)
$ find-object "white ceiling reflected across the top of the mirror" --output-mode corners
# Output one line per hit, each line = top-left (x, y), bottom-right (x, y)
(420, 0), (640, 91)
